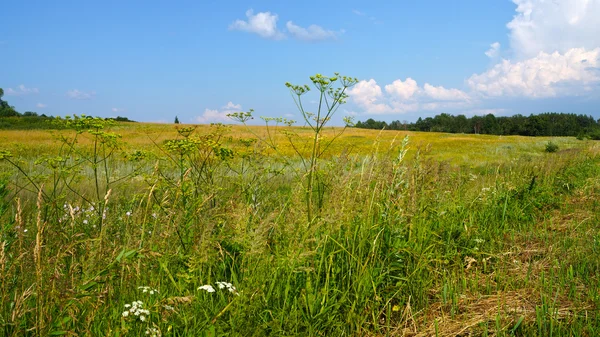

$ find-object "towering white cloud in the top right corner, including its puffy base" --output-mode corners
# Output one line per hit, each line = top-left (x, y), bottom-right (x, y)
(467, 0), (600, 98)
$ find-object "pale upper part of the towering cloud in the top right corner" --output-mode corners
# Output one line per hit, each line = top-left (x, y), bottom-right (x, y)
(507, 0), (600, 60)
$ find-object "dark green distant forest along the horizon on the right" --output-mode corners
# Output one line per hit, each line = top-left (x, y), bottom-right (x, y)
(355, 112), (600, 140)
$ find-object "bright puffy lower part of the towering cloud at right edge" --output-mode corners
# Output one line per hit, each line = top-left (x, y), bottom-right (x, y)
(467, 48), (600, 97)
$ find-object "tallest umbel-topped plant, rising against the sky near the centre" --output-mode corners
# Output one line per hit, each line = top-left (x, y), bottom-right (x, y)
(228, 73), (358, 224)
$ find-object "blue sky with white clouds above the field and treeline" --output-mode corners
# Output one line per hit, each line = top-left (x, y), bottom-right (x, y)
(0, 0), (600, 124)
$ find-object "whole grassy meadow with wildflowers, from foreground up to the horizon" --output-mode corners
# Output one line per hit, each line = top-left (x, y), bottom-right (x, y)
(0, 121), (600, 336)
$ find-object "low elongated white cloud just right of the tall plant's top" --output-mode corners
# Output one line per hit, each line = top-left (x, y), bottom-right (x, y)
(348, 77), (472, 114)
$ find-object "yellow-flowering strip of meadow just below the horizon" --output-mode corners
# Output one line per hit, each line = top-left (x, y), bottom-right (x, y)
(0, 123), (593, 166)
